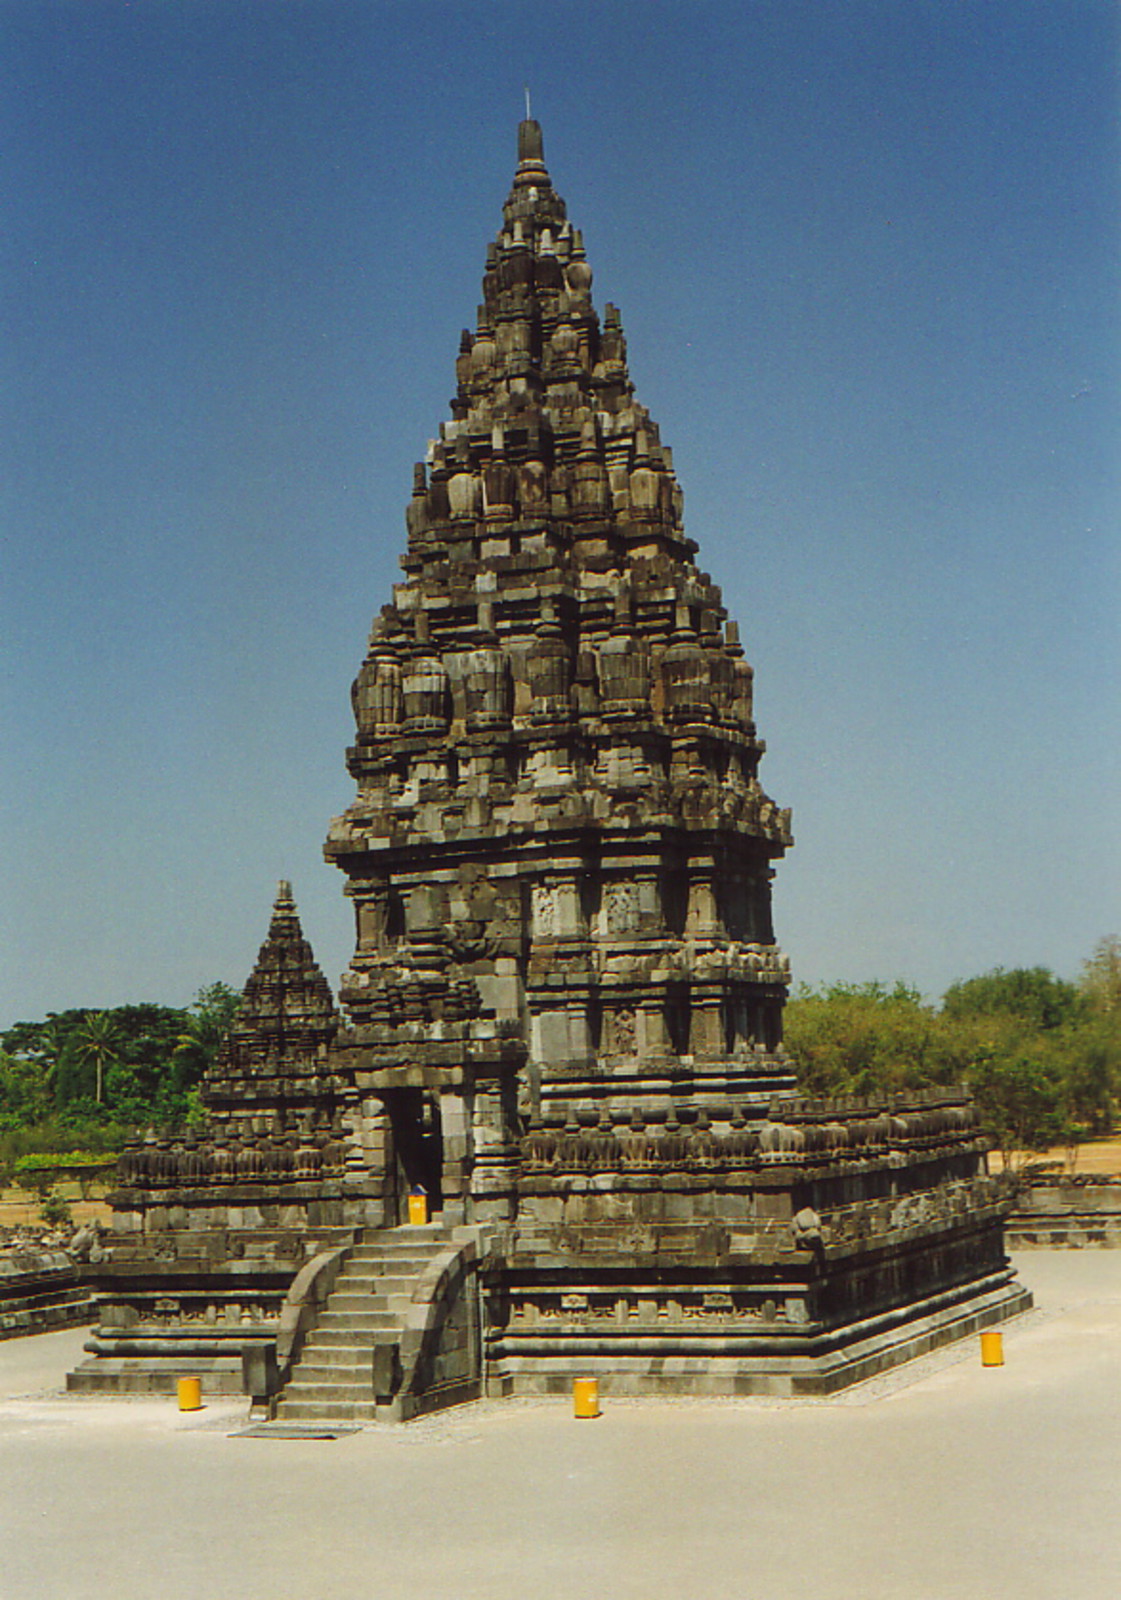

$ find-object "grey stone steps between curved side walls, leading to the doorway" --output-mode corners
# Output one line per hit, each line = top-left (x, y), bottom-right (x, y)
(277, 1222), (449, 1422)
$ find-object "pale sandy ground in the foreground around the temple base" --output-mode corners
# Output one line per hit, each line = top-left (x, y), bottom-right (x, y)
(0, 1251), (1121, 1600)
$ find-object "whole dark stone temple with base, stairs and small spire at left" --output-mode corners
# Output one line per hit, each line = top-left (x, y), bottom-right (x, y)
(70, 122), (1030, 1422)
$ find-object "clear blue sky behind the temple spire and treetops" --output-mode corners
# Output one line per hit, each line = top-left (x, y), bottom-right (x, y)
(0, 0), (1121, 1026)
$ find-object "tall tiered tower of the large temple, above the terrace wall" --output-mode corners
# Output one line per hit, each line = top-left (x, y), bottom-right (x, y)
(326, 122), (792, 1171)
